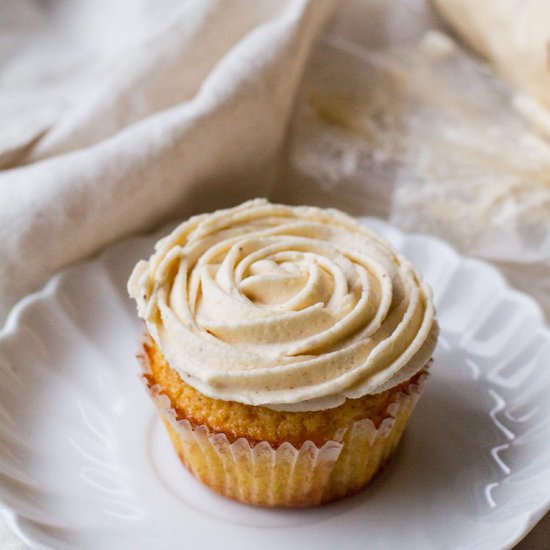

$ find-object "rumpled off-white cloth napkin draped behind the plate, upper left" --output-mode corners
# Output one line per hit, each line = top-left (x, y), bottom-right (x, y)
(0, 0), (331, 323)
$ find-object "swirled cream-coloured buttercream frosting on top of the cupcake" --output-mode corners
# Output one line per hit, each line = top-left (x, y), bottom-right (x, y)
(128, 199), (438, 411)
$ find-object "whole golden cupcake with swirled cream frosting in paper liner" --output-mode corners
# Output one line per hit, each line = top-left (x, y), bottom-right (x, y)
(128, 199), (438, 506)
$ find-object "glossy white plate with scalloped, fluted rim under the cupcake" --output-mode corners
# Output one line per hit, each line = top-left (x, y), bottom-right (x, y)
(0, 220), (550, 550)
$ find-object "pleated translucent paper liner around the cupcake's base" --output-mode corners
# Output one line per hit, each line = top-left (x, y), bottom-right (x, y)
(139, 354), (427, 507)
